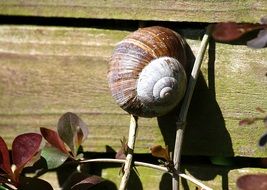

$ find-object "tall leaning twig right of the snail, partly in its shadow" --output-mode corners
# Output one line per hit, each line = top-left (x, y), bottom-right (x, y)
(172, 30), (209, 190)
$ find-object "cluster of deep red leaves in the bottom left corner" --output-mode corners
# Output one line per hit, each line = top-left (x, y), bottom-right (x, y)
(0, 133), (52, 190)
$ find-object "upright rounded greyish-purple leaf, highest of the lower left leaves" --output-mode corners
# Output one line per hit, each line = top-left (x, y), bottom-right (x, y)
(57, 112), (88, 156)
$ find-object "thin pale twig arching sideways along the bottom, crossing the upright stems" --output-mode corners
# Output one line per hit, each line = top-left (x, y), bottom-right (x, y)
(80, 158), (212, 190)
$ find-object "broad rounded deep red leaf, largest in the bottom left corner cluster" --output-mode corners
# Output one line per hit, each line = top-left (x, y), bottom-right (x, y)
(12, 133), (42, 174)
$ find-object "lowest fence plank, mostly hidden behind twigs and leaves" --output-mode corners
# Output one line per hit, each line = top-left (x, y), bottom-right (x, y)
(37, 166), (266, 190)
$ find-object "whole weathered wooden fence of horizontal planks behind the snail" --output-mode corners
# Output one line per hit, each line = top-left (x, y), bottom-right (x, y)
(0, 0), (267, 189)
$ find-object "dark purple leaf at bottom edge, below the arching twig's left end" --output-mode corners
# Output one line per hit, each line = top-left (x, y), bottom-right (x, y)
(71, 175), (104, 190)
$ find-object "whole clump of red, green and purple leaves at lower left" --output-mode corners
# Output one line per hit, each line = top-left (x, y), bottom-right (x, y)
(0, 112), (104, 190)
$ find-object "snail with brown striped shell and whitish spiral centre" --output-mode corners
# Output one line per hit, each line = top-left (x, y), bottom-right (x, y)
(107, 26), (187, 117)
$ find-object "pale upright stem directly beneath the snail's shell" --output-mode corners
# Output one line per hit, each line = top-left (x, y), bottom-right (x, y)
(119, 115), (138, 190)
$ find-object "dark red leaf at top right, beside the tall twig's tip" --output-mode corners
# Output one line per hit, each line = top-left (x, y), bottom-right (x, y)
(212, 22), (266, 42)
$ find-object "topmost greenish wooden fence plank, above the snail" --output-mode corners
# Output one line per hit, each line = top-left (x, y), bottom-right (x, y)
(0, 0), (267, 22)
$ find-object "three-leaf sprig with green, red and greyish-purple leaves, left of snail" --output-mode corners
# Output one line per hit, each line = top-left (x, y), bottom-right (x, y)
(40, 112), (88, 169)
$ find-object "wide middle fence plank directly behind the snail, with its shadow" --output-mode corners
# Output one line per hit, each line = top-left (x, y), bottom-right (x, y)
(0, 25), (267, 157)
